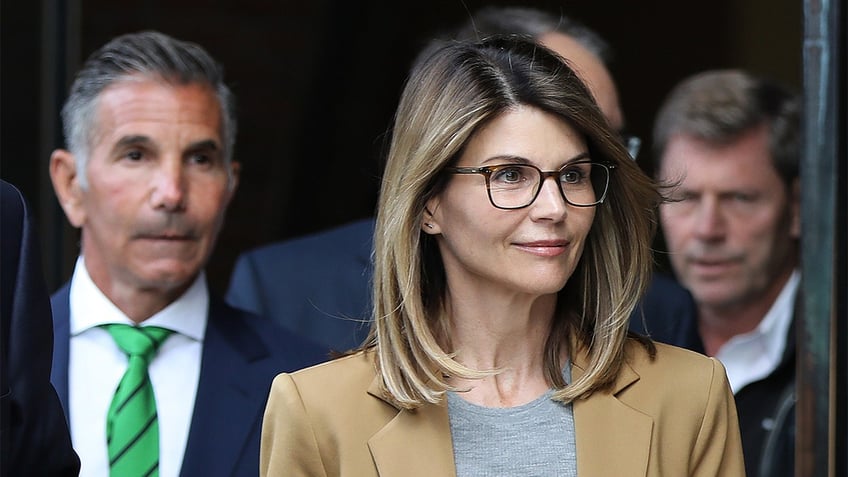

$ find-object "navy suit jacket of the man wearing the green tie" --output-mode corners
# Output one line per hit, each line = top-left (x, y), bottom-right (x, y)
(52, 284), (326, 477)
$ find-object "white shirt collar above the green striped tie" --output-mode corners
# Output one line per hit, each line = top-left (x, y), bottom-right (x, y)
(70, 255), (209, 342)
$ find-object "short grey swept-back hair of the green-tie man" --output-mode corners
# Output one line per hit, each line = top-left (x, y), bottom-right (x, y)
(62, 31), (237, 188)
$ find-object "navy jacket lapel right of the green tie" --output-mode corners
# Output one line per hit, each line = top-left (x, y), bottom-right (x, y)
(181, 297), (270, 476)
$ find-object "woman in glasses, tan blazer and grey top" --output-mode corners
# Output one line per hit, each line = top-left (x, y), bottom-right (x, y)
(260, 38), (744, 477)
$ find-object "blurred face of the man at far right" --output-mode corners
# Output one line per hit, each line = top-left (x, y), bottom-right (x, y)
(659, 128), (799, 310)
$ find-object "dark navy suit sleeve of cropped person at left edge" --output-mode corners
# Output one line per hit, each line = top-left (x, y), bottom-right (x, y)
(0, 181), (80, 476)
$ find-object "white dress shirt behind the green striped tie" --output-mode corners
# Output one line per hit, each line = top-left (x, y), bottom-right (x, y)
(68, 257), (209, 477)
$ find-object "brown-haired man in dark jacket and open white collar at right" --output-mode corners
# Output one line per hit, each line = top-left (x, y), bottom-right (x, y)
(647, 70), (800, 477)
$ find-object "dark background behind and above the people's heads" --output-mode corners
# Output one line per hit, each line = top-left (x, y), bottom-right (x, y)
(0, 0), (802, 291)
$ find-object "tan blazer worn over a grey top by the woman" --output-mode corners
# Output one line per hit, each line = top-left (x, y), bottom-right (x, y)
(260, 342), (745, 477)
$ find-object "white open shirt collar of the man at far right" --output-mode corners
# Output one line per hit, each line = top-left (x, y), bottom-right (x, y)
(715, 270), (800, 394)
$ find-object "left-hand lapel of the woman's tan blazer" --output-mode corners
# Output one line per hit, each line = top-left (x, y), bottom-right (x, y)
(368, 379), (456, 477)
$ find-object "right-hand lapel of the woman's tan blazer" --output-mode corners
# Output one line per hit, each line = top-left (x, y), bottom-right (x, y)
(573, 356), (654, 477)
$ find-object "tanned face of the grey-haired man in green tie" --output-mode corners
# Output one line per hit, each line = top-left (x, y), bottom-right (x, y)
(55, 78), (237, 296)
